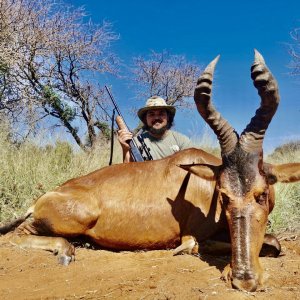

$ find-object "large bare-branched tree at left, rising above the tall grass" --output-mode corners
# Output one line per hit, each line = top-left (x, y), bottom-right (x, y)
(0, 0), (118, 150)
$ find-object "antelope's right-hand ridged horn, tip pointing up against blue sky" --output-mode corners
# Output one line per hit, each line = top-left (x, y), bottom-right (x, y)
(240, 49), (280, 153)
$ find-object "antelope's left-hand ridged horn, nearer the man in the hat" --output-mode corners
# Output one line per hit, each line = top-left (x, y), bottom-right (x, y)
(194, 55), (238, 155)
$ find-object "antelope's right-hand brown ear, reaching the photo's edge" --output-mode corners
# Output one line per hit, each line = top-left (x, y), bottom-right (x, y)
(264, 163), (300, 184)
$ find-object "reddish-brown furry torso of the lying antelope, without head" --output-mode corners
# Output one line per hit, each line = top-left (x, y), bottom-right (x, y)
(1, 149), (298, 262)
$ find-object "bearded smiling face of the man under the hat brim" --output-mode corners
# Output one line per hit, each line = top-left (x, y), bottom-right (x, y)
(146, 109), (168, 133)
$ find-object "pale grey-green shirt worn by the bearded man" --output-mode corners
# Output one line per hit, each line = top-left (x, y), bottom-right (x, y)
(134, 130), (193, 160)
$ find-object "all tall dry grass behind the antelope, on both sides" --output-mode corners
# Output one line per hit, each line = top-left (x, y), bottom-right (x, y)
(0, 120), (300, 232)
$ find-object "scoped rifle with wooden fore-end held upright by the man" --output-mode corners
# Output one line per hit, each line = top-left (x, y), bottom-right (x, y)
(105, 85), (153, 161)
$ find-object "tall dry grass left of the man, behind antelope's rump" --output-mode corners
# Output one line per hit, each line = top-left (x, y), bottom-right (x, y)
(0, 122), (121, 222)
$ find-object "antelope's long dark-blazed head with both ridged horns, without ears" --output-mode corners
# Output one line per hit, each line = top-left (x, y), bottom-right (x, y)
(190, 50), (279, 291)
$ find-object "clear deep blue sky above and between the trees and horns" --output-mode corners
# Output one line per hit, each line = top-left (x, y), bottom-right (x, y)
(65, 0), (300, 153)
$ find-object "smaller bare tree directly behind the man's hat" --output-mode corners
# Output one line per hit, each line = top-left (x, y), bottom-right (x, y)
(133, 51), (200, 107)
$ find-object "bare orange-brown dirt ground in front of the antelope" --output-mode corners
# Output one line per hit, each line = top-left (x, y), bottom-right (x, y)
(0, 236), (300, 300)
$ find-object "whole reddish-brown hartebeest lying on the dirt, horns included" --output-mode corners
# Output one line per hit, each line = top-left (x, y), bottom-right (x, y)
(2, 51), (300, 291)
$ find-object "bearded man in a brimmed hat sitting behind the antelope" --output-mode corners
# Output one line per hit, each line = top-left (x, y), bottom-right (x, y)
(118, 96), (193, 162)
